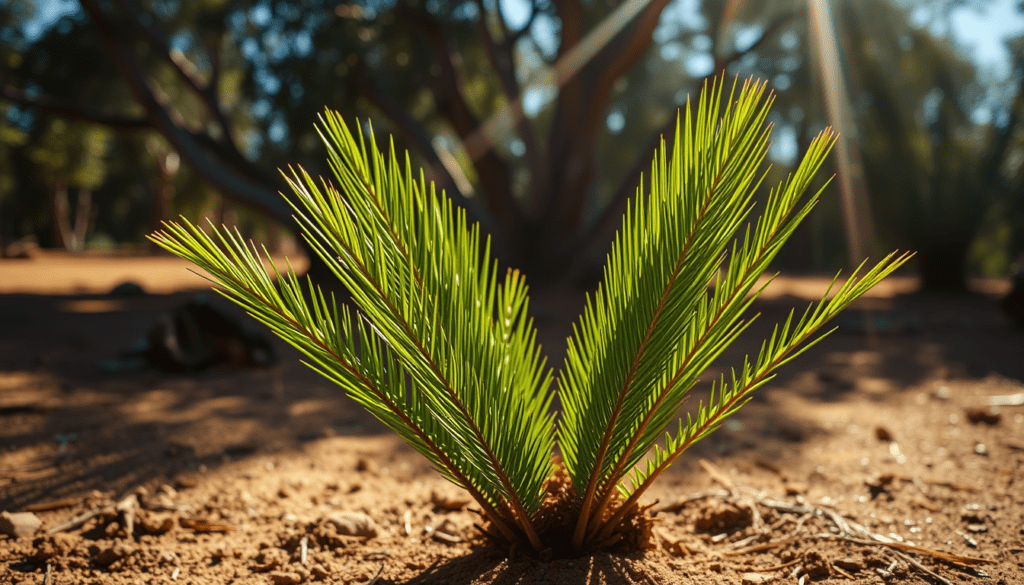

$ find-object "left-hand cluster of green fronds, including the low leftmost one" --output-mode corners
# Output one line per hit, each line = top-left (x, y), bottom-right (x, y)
(154, 112), (554, 540)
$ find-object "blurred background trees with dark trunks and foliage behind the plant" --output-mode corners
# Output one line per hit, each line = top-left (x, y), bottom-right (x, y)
(0, 0), (1024, 288)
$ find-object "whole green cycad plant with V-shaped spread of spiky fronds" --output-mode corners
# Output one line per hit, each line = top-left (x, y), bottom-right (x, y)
(153, 76), (906, 553)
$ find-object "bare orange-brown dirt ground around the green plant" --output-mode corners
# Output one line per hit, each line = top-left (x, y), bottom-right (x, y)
(0, 254), (1024, 585)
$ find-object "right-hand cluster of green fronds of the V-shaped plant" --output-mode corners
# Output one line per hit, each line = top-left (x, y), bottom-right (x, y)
(559, 76), (898, 546)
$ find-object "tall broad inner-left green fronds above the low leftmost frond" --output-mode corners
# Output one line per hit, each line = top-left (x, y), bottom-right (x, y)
(286, 112), (554, 522)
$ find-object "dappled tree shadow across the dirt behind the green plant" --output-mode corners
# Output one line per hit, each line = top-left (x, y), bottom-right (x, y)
(0, 278), (1024, 509)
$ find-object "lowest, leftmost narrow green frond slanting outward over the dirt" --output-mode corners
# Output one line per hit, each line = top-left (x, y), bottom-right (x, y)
(151, 220), (472, 491)
